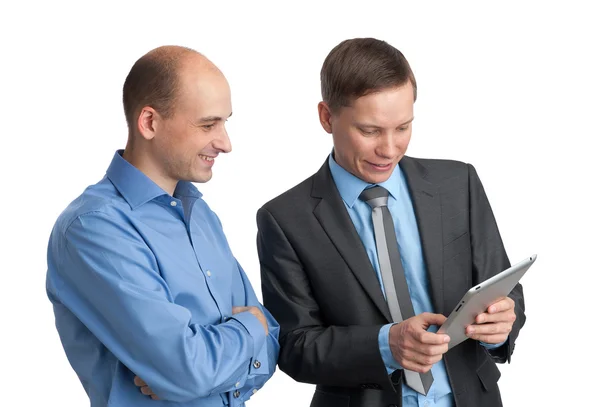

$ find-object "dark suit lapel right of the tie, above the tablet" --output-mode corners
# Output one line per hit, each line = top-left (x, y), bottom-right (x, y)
(400, 156), (444, 313)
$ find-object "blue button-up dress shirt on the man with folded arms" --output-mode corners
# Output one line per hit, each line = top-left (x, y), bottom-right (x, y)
(46, 151), (279, 407)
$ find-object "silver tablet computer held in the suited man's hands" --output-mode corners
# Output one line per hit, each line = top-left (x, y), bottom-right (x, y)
(438, 254), (537, 349)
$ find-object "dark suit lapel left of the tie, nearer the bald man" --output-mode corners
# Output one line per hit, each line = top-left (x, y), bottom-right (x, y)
(312, 160), (392, 322)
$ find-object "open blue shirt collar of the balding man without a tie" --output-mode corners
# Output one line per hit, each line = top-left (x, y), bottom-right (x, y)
(106, 150), (202, 209)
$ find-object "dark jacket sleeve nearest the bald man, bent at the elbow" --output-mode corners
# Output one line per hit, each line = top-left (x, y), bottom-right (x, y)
(257, 208), (391, 388)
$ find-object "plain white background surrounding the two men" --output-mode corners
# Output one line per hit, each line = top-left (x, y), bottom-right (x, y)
(0, 1), (600, 407)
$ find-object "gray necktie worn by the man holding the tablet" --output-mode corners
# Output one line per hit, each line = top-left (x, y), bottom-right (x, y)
(360, 186), (433, 395)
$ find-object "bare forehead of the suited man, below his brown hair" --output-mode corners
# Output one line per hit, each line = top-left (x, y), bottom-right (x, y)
(346, 83), (414, 126)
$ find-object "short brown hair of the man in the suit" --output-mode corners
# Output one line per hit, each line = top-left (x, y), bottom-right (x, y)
(321, 38), (417, 112)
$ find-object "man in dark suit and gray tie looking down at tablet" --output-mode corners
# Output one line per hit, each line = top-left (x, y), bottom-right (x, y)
(257, 38), (525, 407)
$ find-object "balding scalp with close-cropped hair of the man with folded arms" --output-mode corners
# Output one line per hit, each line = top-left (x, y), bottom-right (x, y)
(123, 45), (222, 136)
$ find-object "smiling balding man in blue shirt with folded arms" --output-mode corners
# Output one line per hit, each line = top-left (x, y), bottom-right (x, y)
(47, 47), (279, 407)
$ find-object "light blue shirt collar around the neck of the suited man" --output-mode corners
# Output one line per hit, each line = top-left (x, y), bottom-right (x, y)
(329, 152), (402, 208)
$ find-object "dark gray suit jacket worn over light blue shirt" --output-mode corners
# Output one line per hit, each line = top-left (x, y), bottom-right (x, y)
(257, 156), (525, 407)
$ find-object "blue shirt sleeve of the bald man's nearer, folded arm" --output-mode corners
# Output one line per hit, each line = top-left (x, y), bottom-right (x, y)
(53, 212), (268, 402)
